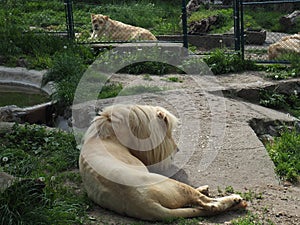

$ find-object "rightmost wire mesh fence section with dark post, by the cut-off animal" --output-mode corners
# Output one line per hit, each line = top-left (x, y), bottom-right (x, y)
(234, 0), (300, 62)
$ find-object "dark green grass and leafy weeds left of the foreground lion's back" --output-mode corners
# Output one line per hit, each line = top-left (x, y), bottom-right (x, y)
(0, 125), (91, 225)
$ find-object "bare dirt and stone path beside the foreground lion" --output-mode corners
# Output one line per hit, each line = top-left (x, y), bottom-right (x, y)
(73, 72), (300, 225)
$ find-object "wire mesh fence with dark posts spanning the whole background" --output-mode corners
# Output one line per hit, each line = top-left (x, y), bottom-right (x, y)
(1, 0), (300, 61)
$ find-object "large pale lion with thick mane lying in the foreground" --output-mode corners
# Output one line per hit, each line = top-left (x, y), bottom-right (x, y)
(79, 105), (246, 221)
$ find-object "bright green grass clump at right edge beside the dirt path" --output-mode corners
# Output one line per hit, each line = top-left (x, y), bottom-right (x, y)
(266, 129), (300, 183)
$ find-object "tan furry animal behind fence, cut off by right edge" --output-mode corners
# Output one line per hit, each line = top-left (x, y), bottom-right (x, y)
(268, 34), (300, 59)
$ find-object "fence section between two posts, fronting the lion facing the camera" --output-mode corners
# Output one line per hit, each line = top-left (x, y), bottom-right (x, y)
(64, 0), (188, 47)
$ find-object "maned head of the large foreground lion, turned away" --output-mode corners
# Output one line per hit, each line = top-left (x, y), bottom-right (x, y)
(85, 105), (178, 170)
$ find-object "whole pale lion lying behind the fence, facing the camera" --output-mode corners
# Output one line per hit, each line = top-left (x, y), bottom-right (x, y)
(91, 14), (157, 41)
